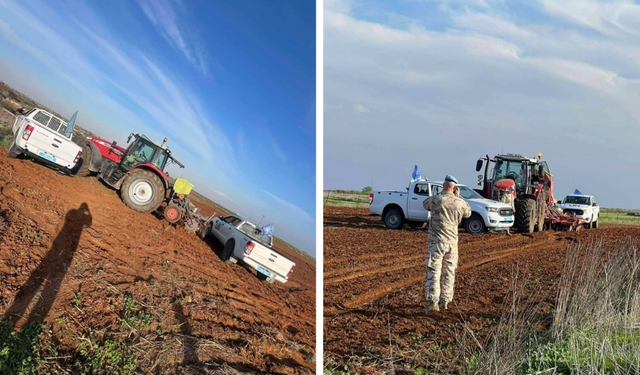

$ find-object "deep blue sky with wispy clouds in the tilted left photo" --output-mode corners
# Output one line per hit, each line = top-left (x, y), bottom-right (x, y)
(0, 0), (316, 256)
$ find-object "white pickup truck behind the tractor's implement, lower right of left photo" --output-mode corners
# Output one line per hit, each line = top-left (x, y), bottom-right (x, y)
(207, 216), (296, 283)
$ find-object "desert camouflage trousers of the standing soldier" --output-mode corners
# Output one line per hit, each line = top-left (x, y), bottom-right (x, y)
(424, 242), (458, 303)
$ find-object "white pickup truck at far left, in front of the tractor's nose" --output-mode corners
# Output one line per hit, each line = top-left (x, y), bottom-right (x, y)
(7, 108), (82, 174)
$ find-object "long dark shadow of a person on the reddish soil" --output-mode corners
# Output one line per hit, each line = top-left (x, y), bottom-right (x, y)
(2, 203), (92, 325)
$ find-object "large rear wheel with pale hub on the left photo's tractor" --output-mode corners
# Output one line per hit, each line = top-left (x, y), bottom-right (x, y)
(120, 169), (165, 213)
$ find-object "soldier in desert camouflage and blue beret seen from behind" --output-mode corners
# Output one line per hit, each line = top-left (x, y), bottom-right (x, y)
(422, 175), (471, 311)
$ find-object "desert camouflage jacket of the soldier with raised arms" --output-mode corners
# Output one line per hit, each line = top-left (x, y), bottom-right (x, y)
(422, 193), (471, 243)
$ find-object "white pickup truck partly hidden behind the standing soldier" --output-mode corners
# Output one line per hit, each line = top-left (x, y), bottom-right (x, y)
(369, 180), (514, 233)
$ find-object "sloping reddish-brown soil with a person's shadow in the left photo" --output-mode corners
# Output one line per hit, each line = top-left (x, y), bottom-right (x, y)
(0, 149), (316, 374)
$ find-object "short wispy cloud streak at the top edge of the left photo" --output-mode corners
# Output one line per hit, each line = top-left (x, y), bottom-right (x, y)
(138, 0), (208, 74)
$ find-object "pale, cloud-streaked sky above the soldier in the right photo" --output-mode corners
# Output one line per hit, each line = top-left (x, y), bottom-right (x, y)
(323, 0), (640, 208)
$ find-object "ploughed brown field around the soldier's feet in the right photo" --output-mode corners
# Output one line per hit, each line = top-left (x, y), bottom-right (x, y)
(324, 207), (640, 374)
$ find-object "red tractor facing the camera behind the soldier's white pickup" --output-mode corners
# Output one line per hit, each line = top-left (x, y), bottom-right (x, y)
(476, 154), (554, 233)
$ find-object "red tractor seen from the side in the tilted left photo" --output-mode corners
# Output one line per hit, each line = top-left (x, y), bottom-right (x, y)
(78, 133), (184, 212)
